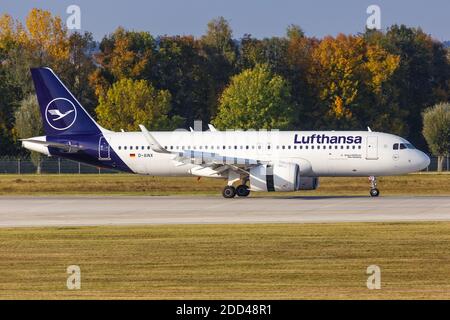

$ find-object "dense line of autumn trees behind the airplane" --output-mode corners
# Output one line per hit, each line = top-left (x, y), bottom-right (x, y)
(0, 9), (450, 156)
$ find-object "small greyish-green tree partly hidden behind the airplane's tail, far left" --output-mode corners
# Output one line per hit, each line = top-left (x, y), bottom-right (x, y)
(14, 94), (43, 174)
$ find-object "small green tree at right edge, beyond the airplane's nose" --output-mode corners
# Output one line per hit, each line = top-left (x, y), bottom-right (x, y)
(422, 103), (450, 171)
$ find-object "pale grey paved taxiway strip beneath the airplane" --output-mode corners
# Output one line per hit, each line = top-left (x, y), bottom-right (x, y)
(0, 196), (450, 227)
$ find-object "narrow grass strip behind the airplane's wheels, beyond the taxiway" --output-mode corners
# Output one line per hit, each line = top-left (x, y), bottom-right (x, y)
(0, 174), (450, 196)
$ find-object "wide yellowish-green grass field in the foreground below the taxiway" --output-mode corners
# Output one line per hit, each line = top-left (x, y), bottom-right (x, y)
(0, 222), (450, 299)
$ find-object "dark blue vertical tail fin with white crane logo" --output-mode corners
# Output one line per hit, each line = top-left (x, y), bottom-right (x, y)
(31, 68), (101, 136)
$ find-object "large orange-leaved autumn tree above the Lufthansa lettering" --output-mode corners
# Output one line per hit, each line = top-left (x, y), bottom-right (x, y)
(309, 34), (399, 129)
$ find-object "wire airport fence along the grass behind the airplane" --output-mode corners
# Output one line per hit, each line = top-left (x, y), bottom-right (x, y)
(0, 157), (450, 174)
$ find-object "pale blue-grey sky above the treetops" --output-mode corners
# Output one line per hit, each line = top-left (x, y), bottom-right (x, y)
(0, 0), (450, 41)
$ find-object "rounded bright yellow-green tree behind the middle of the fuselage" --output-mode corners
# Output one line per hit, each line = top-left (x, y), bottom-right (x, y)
(213, 65), (295, 129)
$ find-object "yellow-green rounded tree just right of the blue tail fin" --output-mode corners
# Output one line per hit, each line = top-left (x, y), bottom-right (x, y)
(96, 78), (180, 131)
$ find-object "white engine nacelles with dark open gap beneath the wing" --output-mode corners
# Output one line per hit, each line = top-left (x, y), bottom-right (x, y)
(250, 162), (319, 192)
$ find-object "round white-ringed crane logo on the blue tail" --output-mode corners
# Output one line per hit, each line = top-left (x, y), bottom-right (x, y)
(45, 98), (77, 131)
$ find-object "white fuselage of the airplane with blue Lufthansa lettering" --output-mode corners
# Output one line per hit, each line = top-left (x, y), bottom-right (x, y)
(104, 131), (429, 177)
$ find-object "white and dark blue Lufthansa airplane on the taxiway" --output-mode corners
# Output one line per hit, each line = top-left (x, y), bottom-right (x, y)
(22, 68), (430, 198)
